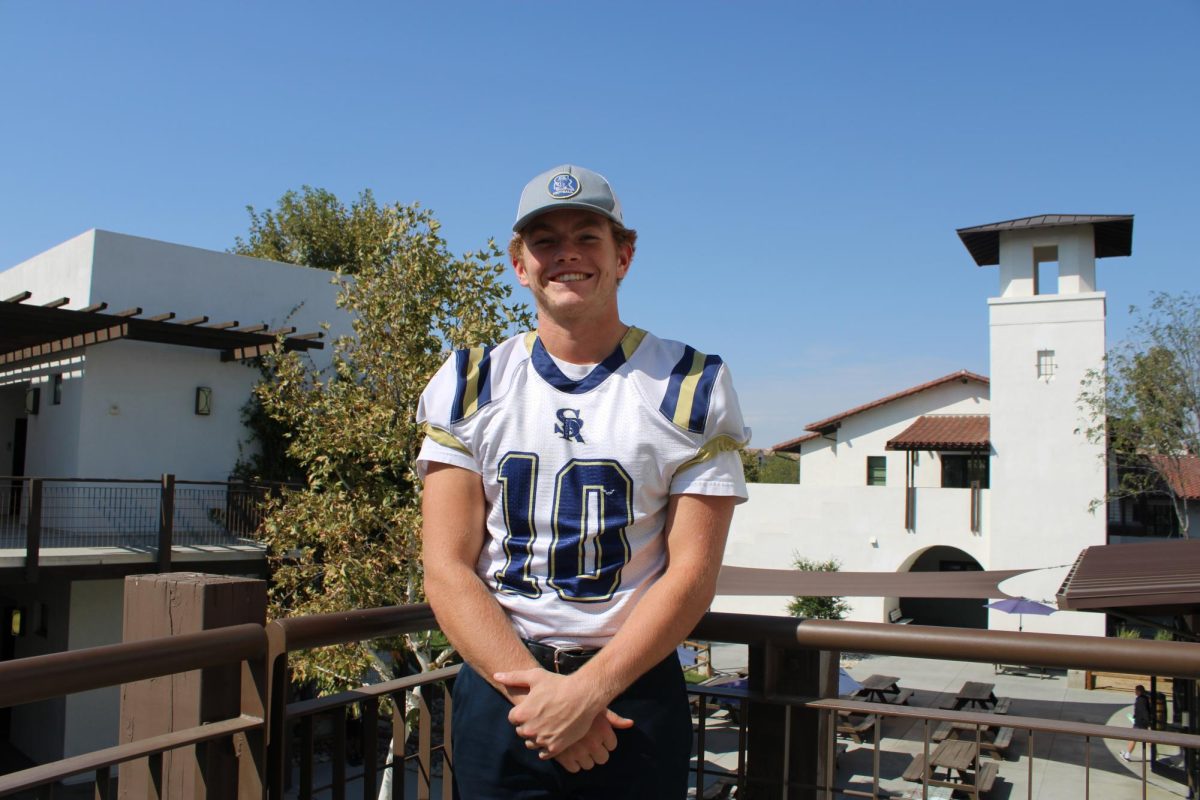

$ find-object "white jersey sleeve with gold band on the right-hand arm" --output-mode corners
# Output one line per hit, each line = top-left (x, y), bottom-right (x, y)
(671, 363), (750, 503)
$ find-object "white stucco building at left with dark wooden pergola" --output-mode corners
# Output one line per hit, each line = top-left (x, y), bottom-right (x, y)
(0, 230), (349, 762)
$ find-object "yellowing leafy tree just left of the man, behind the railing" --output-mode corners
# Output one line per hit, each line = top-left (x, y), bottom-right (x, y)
(239, 187), (530, 690)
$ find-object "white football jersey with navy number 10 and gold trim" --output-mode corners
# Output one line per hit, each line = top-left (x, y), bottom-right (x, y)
(418, 327), (750, 646)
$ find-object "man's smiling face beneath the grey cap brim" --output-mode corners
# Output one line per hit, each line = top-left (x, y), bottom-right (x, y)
(512, 209), (634, 333)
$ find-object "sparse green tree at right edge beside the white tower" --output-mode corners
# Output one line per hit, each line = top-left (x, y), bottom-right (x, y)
(1079, 293), (1200, 537)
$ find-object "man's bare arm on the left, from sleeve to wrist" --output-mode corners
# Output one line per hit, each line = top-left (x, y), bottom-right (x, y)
(421, 463), (538, 702)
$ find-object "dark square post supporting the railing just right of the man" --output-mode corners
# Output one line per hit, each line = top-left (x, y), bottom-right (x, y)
(739, 643), (821, 800)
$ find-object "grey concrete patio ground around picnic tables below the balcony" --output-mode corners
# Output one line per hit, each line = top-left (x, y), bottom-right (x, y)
(706, 645), (1187, 800)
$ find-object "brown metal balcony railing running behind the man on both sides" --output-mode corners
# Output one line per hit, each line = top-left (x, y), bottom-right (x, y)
(0, 606), (1200, 800)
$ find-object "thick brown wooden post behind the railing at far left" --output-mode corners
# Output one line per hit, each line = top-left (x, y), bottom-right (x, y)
(118, 572), (266, 800)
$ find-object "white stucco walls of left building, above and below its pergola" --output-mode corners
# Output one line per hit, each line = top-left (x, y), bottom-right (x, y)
(0, 230), (350, 480)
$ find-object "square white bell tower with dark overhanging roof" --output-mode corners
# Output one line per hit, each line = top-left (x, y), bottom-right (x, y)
(958, 215), (1133, 634)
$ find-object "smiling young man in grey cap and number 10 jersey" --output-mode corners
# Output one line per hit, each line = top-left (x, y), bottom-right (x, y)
(418, 166), (750, 800)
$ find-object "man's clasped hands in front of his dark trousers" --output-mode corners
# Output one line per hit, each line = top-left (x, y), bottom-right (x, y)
(493, 668), (634, 772)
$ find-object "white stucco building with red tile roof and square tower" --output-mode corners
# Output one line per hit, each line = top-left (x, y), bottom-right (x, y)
(714, 216), (1133, 634)
